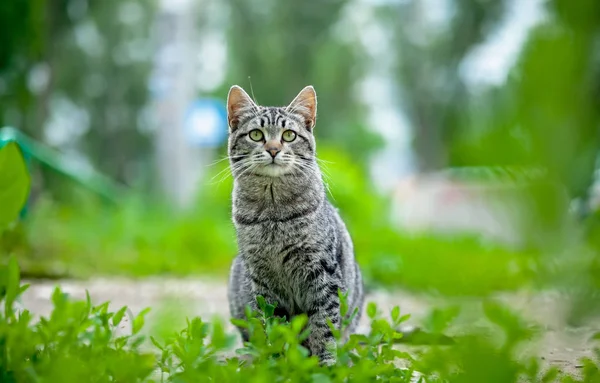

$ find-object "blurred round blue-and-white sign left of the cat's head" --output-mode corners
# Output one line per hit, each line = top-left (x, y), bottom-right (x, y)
(183, 99), (227, 148)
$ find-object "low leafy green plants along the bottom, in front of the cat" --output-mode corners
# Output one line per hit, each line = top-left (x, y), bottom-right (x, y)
(0, 258), (600, 383)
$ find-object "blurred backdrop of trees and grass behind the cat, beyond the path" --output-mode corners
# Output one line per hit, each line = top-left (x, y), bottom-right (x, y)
(0, 0), (600, 308)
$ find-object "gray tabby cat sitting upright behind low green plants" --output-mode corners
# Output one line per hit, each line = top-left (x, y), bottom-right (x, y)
(227, 86), (363, 365)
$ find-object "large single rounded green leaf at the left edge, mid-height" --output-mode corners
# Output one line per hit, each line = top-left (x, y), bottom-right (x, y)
(0, 142), (30, 232)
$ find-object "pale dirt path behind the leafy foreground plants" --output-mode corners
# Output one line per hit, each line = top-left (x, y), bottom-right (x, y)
(22, 279), (600, 373)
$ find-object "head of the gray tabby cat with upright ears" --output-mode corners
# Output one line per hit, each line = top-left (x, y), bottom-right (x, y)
(227, 85), (317, 177)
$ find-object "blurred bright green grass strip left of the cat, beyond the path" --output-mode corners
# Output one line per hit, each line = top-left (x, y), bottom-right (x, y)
(0, 182), (236, 277)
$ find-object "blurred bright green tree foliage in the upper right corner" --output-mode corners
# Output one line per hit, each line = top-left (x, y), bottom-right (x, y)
(451, 0), (600, 208)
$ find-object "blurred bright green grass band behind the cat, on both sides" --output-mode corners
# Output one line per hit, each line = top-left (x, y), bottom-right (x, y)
(0, 148), (548, 295)
